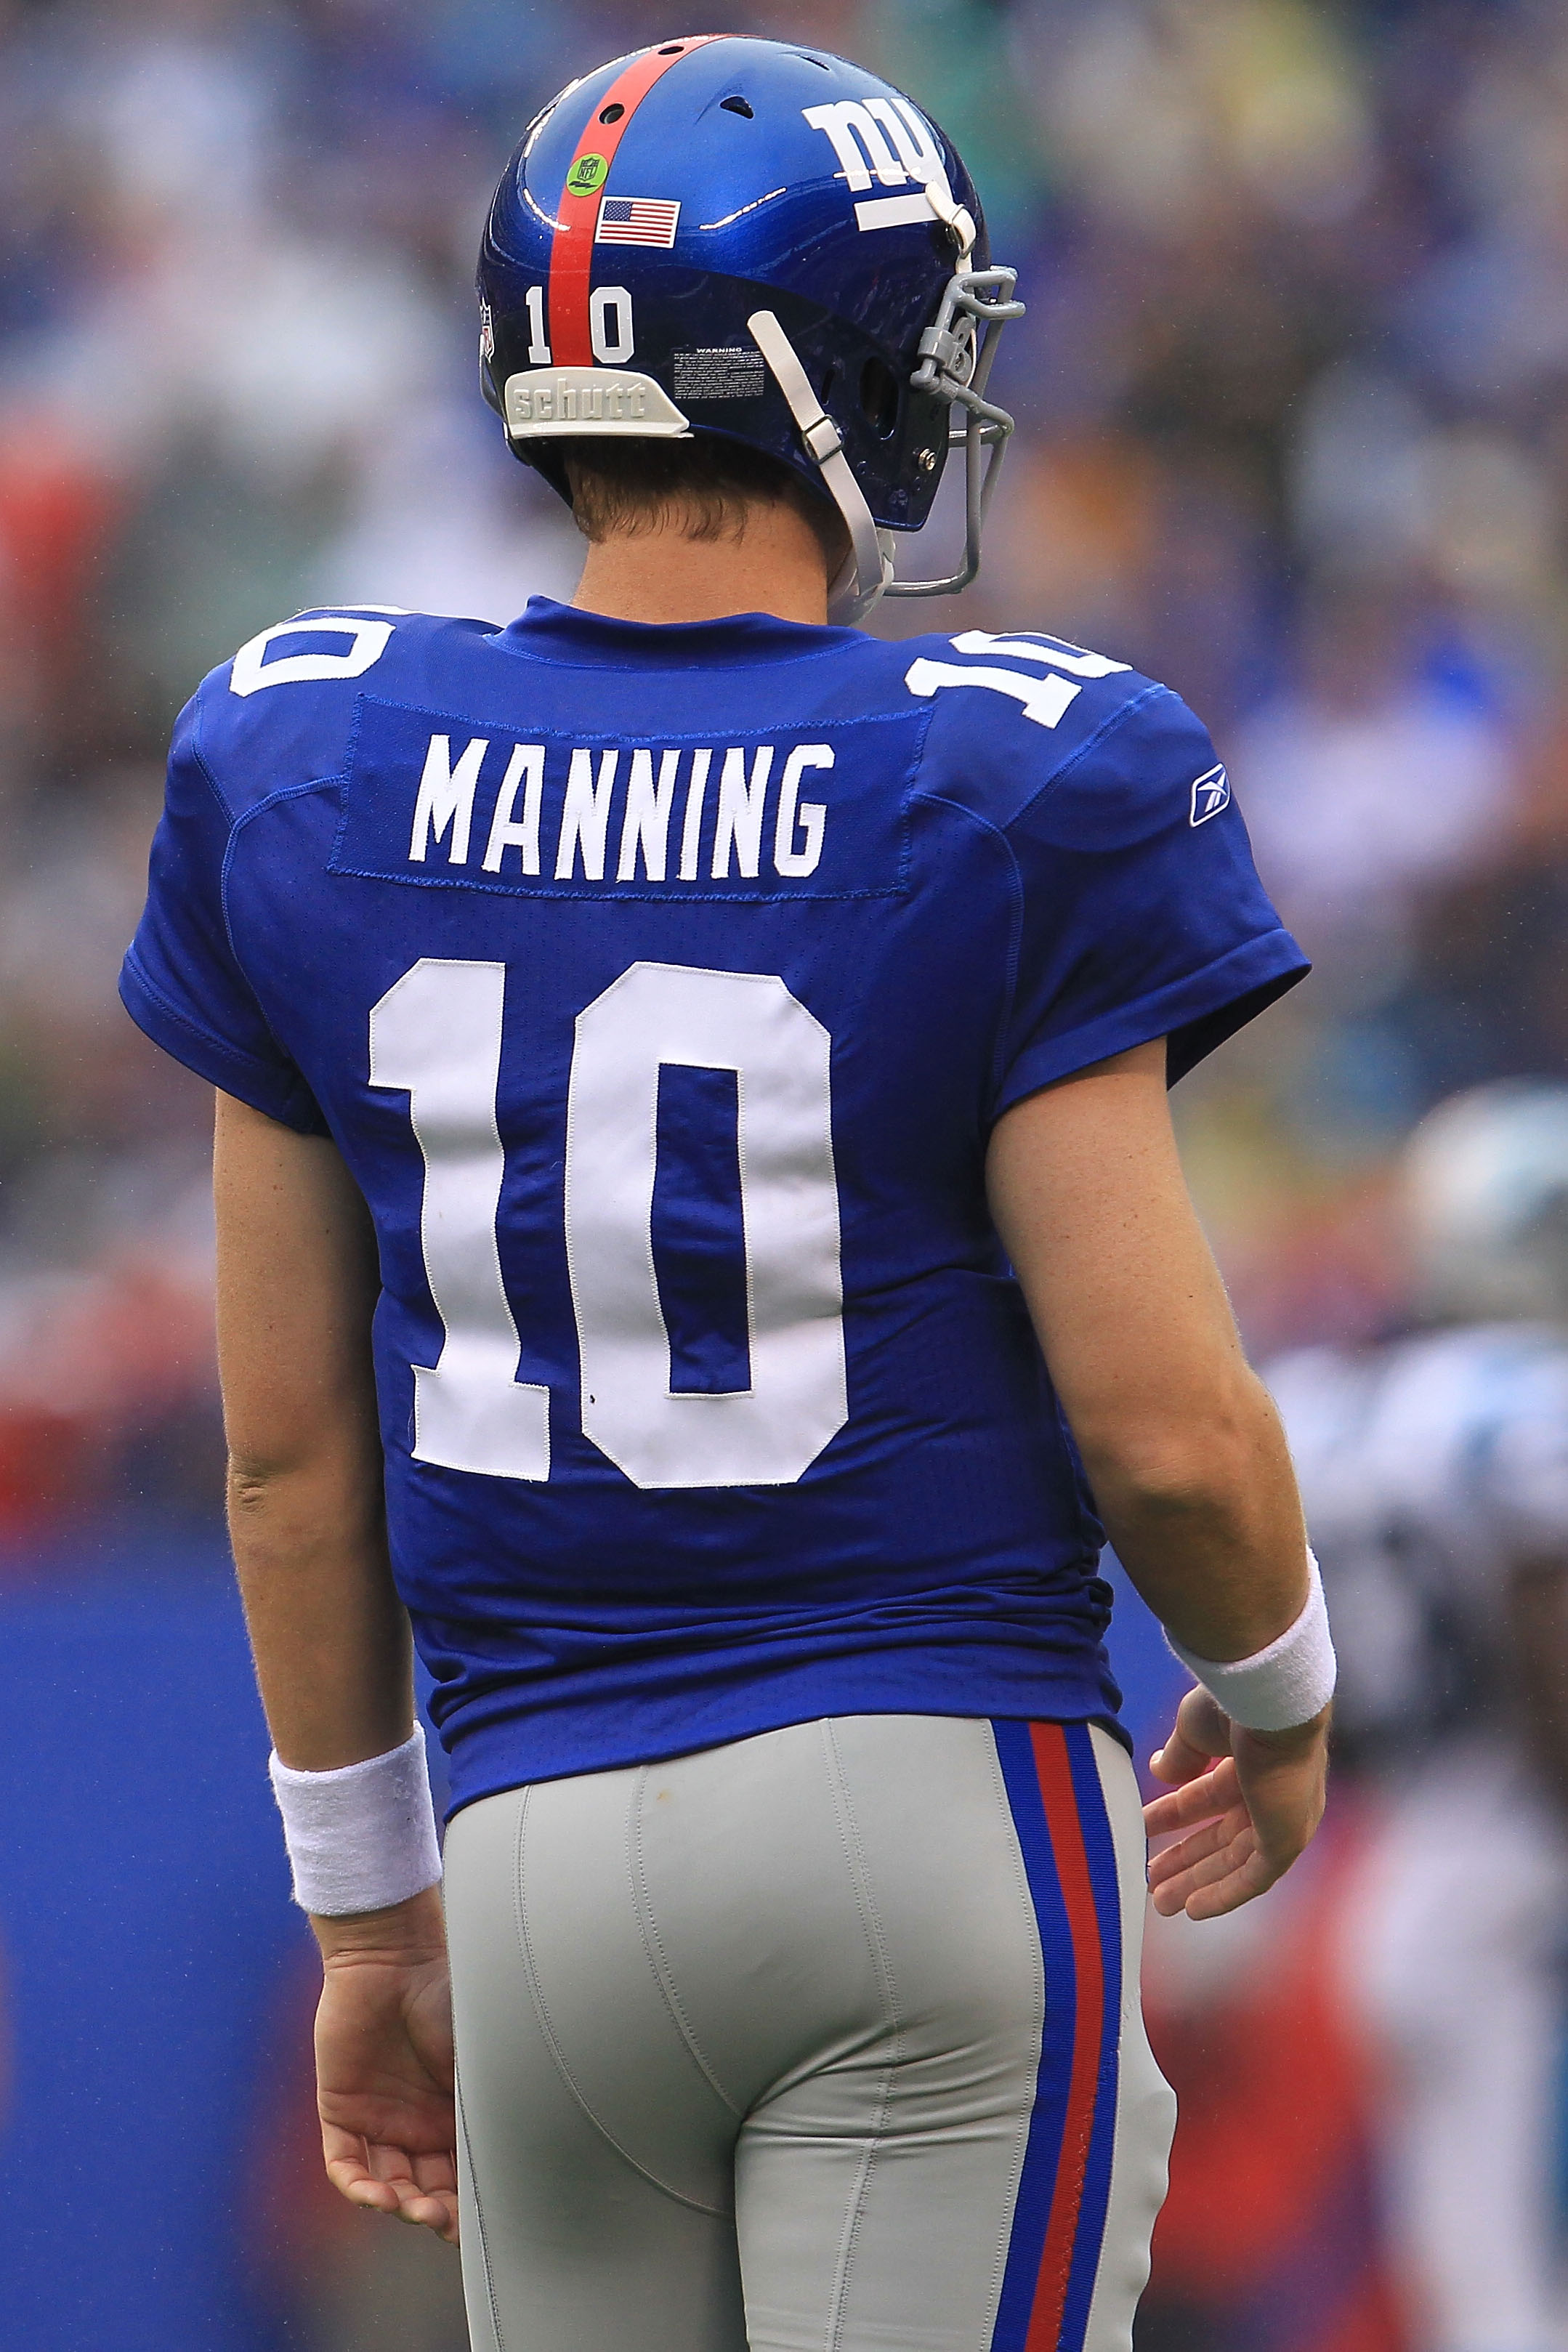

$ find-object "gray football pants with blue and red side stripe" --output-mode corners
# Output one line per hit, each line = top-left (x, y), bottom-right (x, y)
(447, 1715), (1176, 2352)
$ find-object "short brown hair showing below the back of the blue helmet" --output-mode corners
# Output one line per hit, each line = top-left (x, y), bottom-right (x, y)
(557, 435), (849, 578)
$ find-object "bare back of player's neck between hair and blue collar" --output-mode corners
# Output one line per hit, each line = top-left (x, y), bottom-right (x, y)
(571, 501), (828, 628)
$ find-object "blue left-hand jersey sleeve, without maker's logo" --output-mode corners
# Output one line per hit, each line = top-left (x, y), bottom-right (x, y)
(120, 696), (327, 1133)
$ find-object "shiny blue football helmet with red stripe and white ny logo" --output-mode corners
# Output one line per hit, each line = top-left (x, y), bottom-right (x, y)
(477, 36), (1022, 621)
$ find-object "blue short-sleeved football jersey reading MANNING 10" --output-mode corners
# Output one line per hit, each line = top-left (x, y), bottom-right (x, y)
(122, 599), (1305, 1804)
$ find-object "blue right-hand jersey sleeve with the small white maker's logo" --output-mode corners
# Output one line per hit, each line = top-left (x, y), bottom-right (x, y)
(997, 687), (1309, 1115)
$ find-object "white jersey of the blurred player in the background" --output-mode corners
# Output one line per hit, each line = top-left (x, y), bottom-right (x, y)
(1265, 1324), (1568, 1745)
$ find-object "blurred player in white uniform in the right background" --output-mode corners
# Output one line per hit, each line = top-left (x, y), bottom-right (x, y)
(1267, 1080), (1568, 2352)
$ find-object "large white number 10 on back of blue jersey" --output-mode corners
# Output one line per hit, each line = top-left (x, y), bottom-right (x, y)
(369, 957), (849, 1487)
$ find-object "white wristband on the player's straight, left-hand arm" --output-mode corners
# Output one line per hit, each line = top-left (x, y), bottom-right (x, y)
(268, 1724), (442, 1919)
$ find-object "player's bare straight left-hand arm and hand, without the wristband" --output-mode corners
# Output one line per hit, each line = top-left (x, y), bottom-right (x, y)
(214, 1094), (456, 2242)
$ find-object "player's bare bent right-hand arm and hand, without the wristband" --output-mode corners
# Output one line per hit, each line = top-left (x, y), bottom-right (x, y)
(987, 1040), (1328, 1919)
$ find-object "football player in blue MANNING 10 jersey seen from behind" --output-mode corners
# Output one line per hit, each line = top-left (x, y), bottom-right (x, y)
(124, 38), (1333, 2352)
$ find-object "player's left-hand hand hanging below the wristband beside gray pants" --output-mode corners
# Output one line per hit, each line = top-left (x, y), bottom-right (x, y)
(310, 1886), (458, 2246)
